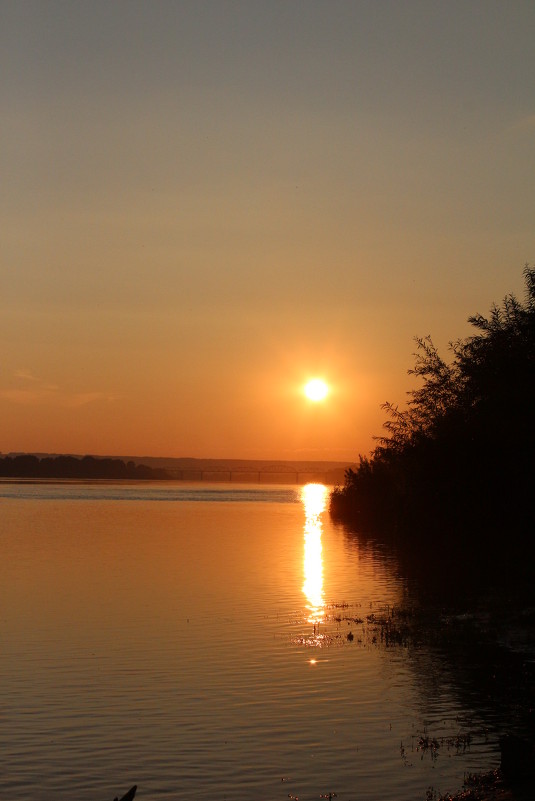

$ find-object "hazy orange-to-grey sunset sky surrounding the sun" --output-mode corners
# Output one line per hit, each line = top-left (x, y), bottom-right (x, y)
(0, 0), (535, 461)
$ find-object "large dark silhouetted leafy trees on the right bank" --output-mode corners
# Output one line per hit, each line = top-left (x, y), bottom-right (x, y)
(330, 266), (535, 548)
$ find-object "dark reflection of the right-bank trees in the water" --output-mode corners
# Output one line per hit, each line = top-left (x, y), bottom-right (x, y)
(339, 525), (535, 763)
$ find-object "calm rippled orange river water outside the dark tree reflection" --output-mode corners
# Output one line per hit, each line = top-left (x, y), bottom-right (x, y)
(0, 483), (498, 801)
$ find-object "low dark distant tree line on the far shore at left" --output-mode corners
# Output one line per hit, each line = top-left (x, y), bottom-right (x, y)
(0, 454), (172, 480)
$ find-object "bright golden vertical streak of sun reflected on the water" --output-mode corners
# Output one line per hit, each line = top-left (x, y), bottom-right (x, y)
(301, 484), (327, 625)
